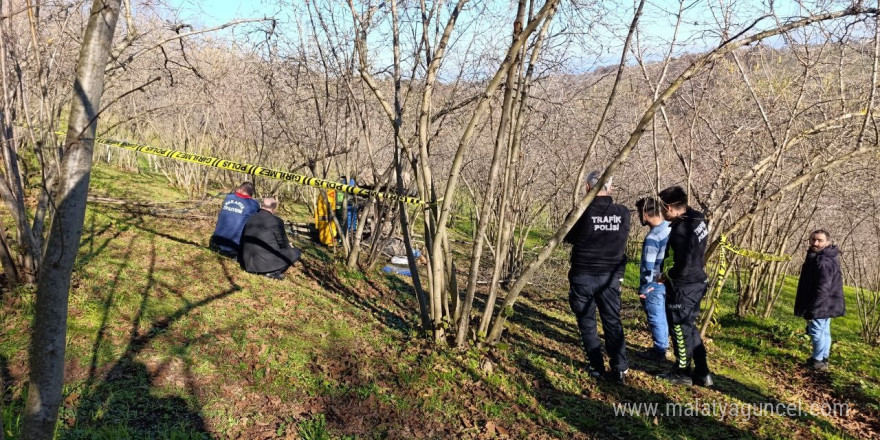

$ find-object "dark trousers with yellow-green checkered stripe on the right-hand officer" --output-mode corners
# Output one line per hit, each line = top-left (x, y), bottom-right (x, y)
(666, 283), (709, 376)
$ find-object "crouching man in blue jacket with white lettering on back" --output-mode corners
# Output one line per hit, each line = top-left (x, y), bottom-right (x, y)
(210, 182), (260, 258)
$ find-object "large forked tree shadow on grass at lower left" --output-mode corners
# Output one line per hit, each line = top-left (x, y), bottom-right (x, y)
(66, 237), (240, 439)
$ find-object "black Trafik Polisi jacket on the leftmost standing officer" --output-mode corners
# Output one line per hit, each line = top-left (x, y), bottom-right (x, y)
(565, 196), (630, 278)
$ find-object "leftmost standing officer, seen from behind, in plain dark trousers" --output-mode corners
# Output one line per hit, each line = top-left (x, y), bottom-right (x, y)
(565, 171), (630, 384)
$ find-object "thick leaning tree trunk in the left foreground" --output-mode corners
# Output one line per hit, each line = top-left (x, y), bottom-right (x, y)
(22, 0), (121, 439)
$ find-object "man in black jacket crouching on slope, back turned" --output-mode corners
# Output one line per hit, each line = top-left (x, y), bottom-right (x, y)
(240, 197), (301, 280)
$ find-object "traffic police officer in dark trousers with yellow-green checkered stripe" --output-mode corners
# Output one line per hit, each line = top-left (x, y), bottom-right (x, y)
(659, 186), (713, 387)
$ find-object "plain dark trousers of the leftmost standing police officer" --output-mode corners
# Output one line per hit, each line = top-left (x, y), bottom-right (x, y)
(568, 274), (629, 372)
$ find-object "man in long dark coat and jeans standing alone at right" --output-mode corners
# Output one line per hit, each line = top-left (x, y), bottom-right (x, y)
(794, 229), (846, 371)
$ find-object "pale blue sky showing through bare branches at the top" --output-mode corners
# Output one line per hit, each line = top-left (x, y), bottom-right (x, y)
(166, 0), (868, 73)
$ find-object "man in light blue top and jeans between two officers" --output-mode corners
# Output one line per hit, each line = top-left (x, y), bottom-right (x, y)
(636, 197), (670, 361)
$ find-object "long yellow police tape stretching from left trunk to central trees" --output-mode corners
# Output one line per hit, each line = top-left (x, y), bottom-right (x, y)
(91, 133), (428, 205)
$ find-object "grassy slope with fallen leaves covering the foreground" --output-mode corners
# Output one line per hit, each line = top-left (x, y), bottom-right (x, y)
(0, 163), (880, 439)
